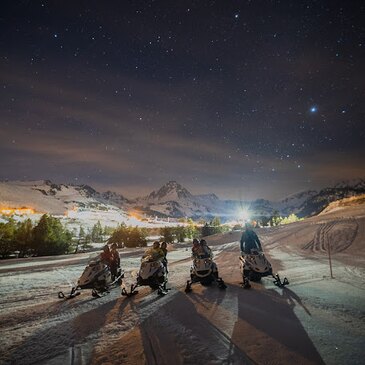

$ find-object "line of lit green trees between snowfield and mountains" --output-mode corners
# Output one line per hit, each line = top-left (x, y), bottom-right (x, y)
(0, 213), (300, 258)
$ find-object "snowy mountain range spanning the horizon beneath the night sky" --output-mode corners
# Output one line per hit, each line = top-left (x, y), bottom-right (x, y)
(0, 179), (365, 220)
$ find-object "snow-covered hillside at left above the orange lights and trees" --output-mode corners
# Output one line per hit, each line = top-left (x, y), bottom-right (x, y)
(0, 180), (140, 228)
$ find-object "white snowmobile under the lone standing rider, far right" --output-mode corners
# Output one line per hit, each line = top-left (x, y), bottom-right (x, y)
(239, 249), (289, 289)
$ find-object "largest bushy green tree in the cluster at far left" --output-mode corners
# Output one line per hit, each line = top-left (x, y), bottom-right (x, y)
(32, 214), (72, 256)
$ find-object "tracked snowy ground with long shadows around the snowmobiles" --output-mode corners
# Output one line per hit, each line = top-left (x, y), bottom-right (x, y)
(0, 203), (365, 365)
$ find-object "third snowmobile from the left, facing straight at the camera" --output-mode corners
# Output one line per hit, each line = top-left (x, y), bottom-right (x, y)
(185, 255), (227, 293)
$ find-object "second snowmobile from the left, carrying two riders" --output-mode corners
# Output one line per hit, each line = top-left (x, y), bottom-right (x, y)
(122, 255), (168, 297)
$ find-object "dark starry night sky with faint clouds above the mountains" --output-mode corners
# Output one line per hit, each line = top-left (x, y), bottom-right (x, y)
(0, 0), (365, 199)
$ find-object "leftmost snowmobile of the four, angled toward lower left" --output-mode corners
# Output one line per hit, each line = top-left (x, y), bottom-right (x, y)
(58, 255), (124, 299)
